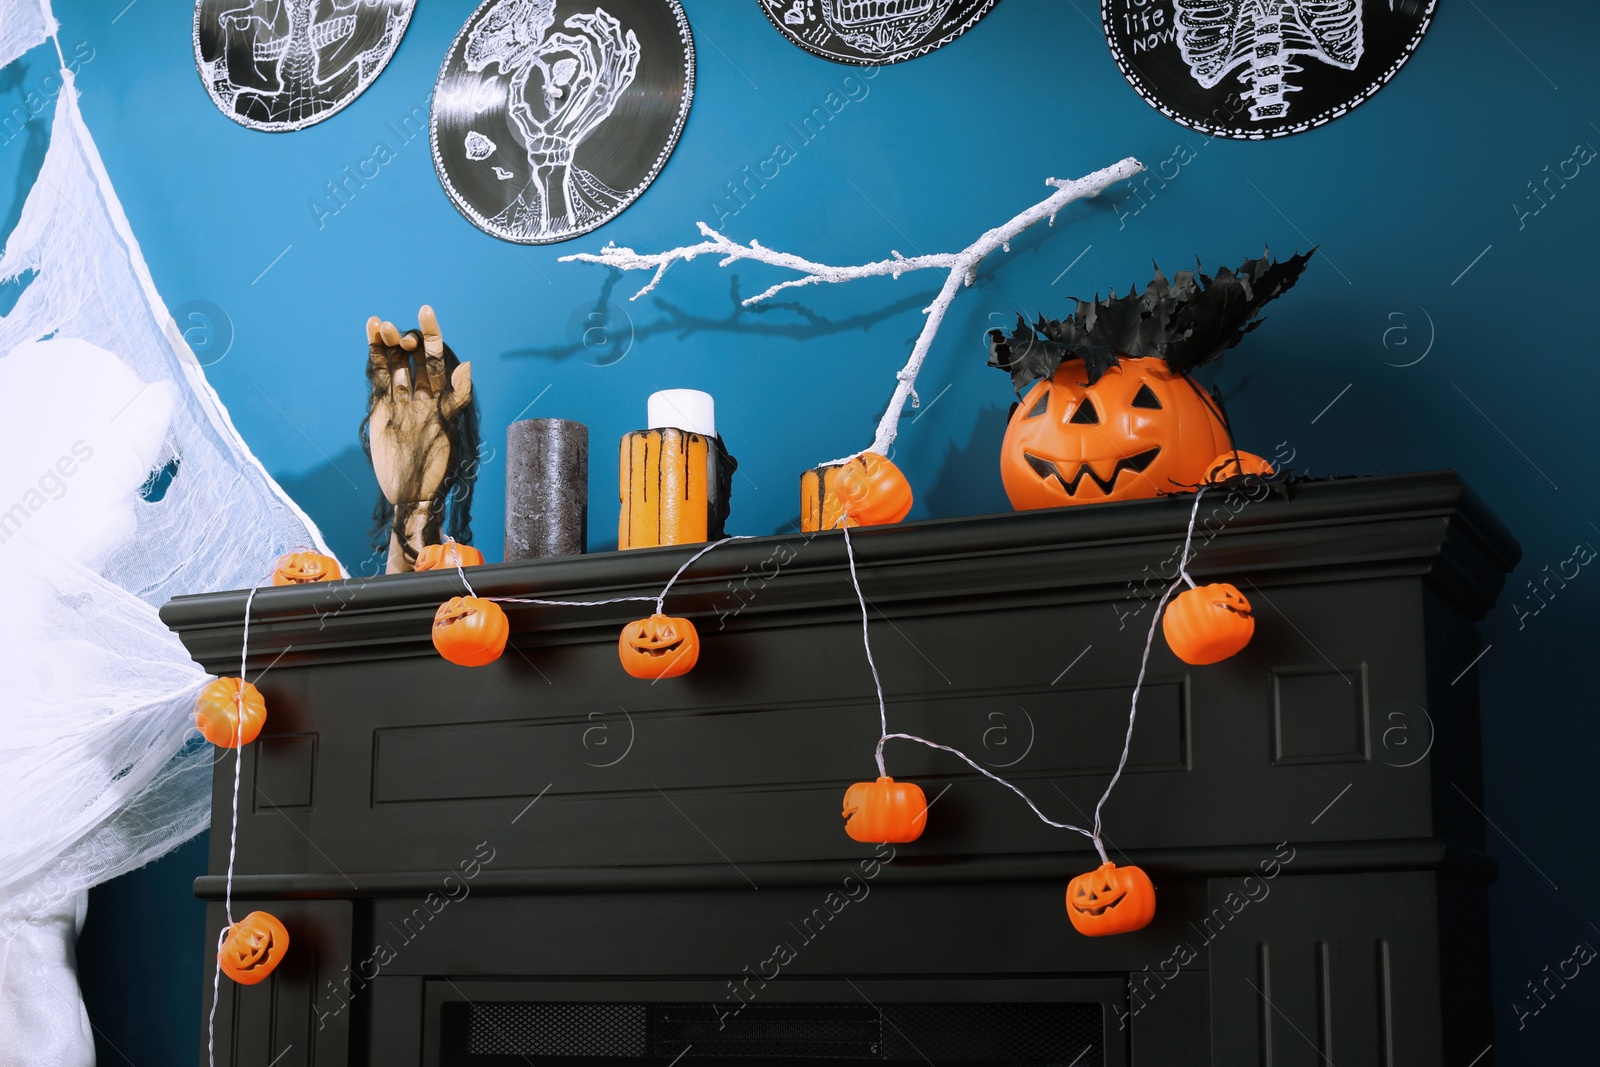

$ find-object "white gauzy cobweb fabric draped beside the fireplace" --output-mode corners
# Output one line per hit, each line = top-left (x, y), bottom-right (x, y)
(0, 41), (328, 1067)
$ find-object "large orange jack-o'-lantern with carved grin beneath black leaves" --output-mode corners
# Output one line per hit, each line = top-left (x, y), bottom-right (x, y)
(1000, 357), (1230, 510)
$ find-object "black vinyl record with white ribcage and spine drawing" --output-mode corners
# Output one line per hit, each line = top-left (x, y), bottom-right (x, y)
(1101, 0), (1437, 139)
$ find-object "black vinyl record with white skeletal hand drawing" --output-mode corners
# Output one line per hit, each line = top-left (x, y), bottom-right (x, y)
(432, 0), (694, 245)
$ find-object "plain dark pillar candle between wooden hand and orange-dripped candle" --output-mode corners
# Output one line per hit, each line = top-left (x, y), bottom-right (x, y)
(506, 419), (589, 563)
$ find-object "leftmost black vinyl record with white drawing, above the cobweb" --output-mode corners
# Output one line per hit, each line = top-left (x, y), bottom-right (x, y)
(195, 0), (416, 131)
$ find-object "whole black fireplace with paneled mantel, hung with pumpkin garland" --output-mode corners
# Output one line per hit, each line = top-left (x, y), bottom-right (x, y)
(163, 472), (1518, 1067)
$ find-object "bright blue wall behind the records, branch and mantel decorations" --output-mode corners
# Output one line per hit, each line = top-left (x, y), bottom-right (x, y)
(0, 0), (1600, 1064)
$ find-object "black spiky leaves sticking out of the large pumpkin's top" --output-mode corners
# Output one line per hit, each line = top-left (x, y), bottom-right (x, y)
(989, 248), (1317, 392)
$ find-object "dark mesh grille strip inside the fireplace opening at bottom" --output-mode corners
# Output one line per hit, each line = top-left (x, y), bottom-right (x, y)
(460, 1003), (1104, 1067)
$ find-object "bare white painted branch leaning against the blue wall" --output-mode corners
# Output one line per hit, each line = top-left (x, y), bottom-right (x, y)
(562, 157), (1144, 462)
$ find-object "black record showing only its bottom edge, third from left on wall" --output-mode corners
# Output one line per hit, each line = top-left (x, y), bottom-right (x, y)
(760, 0), (997, 67)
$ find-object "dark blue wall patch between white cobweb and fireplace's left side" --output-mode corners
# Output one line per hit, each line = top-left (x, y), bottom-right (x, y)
(78, 833), (211, 1067)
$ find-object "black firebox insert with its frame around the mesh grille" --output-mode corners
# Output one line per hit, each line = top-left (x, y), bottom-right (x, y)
(424, 979), (1126, 1067)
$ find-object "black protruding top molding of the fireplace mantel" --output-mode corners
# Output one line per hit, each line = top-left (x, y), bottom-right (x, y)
(162, 470), (1522, 673)
